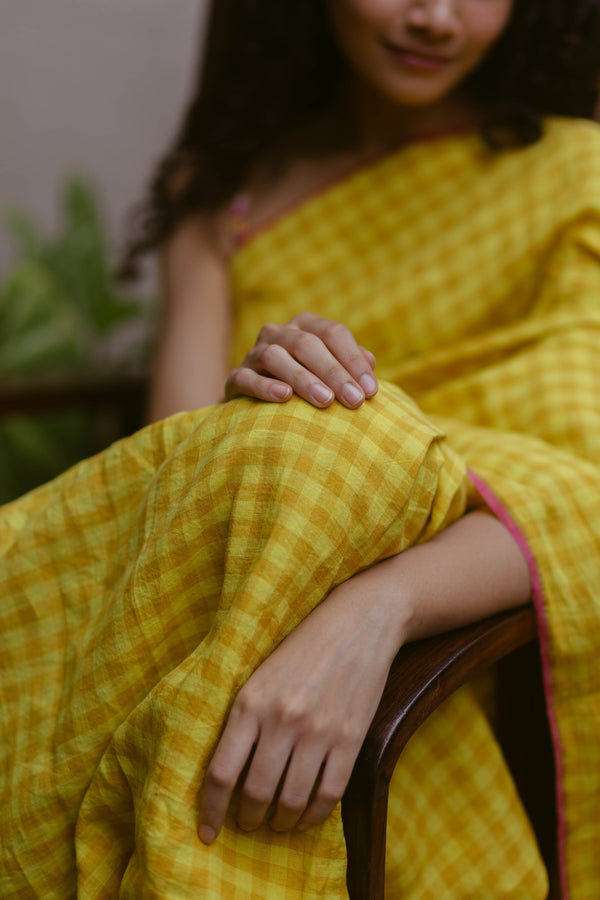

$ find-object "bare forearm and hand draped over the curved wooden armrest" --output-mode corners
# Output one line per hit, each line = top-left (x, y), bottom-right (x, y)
(199, 512), (531, 843)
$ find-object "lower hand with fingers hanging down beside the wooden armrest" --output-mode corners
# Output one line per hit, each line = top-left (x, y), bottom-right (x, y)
(199, 579), (398, 843)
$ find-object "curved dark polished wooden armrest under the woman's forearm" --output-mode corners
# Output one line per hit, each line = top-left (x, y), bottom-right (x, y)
(342, 606), (537, 900)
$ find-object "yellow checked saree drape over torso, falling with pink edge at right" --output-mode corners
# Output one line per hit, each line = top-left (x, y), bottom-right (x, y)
(234, 119), (600, 898)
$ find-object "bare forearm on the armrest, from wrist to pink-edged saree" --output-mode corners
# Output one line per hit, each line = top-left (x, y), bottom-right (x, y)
(336, 511), (531, 649)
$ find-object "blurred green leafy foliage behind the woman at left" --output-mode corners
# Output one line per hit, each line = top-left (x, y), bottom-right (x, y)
(0, 177), (152, 503)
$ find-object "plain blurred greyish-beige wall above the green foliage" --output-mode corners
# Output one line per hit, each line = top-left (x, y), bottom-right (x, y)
(0, 0), (207, 272)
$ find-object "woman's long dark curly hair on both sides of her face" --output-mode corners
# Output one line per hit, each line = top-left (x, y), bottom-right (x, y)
(120, 0), (600, 278)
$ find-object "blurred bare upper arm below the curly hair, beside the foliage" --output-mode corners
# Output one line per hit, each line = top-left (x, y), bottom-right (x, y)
(149, 217), (231, 421)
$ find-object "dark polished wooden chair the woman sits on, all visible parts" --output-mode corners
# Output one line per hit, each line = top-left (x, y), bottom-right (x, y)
(0, 374), (556, 900)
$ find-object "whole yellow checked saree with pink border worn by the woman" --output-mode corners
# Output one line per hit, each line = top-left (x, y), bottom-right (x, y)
(0, 120), (600, 900)
